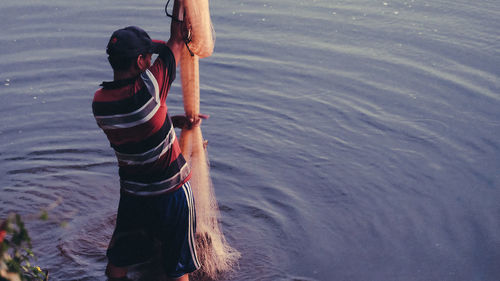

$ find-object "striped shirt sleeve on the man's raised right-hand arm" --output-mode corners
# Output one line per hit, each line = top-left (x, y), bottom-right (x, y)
(149, 40), (176, 102)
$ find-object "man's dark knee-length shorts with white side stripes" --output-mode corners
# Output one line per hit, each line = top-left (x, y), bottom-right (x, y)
(106, 182), (200, 277)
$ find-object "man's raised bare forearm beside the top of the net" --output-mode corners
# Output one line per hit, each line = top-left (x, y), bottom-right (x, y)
(167, 0), (185, 66)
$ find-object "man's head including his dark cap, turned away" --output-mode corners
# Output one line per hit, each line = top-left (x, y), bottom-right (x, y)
(106, 26), (156, 72)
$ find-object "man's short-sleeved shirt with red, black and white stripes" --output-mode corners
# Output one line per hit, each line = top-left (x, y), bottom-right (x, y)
(92, 42), (191, 196)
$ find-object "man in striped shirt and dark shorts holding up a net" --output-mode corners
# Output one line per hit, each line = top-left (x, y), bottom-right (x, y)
(92, 1), (204, 280)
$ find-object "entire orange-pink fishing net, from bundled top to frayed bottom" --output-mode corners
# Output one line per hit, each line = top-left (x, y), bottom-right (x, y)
(165, 0), (240, 279)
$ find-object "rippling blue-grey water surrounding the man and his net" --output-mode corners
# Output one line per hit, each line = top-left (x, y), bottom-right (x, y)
(0, 0), (500, 281)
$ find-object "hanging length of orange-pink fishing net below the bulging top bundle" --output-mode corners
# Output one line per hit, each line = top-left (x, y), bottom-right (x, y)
(180, 24), (240, 279)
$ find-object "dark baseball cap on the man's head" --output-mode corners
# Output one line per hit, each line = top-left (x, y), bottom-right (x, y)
(106, 26), (157, 57)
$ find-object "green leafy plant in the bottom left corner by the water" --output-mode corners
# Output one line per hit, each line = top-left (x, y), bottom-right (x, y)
(0, 214), (48, 281)
